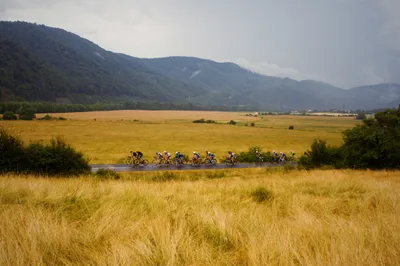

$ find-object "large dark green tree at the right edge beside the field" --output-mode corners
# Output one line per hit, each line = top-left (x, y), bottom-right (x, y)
(343, 106), (400, 169)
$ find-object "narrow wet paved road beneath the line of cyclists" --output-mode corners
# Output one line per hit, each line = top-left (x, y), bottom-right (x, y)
(91, 163), (297, 172)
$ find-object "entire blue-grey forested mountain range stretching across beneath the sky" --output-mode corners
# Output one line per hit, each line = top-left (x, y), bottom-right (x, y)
(0, 19), (400, 110)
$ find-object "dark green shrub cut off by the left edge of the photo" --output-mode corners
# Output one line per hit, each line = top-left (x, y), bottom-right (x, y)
(0, 128), (26, 172)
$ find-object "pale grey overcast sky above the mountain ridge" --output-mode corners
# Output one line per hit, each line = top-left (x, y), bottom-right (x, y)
(0, 0), (400, 88)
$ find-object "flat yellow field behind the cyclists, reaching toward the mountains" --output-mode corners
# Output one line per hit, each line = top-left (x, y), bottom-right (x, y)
(0, 111), (357, 163)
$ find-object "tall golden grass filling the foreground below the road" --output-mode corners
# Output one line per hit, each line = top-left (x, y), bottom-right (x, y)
(0, 169), (400, 265)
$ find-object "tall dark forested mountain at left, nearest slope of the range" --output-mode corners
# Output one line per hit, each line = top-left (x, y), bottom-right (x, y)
(0, 22), (205, 102)
